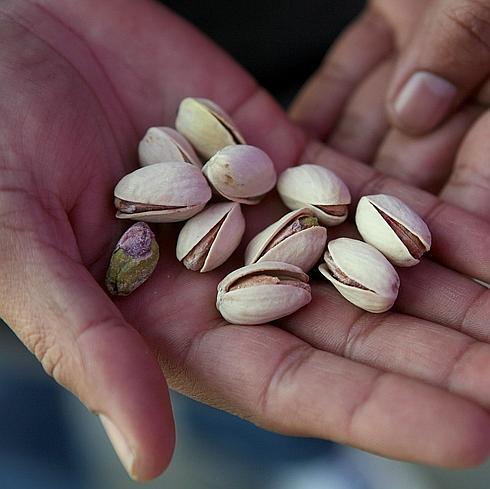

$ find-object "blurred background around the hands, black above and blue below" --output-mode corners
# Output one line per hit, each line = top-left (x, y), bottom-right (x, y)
(0, 0), (490, 489)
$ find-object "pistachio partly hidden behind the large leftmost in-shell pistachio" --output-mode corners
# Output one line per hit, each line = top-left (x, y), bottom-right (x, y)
(138, 127), (202, 168)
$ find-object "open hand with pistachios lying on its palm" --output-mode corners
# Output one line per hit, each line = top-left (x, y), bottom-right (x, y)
(0, 0), (490, 479)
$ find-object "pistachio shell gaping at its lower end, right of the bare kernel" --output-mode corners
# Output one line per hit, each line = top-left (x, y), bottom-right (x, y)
(177, 202), (245, 272)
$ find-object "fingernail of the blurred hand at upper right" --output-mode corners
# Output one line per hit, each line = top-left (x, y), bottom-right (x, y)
(393, 71), (457, 132)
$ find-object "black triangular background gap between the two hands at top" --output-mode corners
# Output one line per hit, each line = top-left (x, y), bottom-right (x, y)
(162, 0), (366, 104)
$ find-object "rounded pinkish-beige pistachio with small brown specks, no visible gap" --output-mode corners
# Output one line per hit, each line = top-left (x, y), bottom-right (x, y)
(202, 144), (277, 205)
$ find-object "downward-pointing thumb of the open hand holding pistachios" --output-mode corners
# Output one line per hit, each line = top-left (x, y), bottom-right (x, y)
(0, 203), (174, 480)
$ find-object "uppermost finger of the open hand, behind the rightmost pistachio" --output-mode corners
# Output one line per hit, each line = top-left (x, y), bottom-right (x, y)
(300, 142), (490, 282)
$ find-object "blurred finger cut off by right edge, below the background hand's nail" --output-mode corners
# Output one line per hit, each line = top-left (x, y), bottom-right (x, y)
(441, 111), (490, 221)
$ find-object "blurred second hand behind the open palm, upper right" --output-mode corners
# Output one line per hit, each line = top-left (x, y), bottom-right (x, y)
(291, 0), (490, 219)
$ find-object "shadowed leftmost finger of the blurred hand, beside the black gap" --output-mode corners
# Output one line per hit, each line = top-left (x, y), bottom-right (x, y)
(290, 8), (392, 139)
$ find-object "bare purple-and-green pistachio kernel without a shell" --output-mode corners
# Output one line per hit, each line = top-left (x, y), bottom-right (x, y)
(105, 222), (159, 295)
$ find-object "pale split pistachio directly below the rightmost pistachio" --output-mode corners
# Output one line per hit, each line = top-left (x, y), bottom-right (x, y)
(319, 238), (400, 313)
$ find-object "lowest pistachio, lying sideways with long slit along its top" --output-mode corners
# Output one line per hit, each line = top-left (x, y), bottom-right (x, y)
(216, 262), (311, 324)
